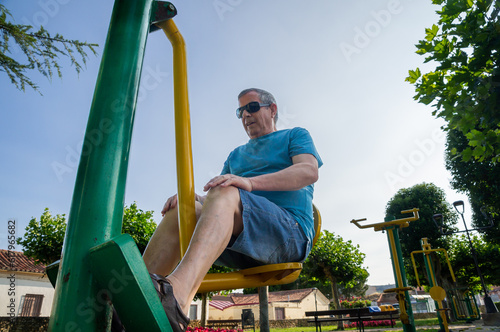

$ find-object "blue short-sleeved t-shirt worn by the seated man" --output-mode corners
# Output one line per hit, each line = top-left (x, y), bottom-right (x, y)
(221, 127), (323, 243)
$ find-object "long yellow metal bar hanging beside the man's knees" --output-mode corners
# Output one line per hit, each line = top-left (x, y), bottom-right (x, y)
(157, 19), (196, 256)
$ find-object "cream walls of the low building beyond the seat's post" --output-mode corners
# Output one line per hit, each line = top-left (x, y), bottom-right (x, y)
(208, 292), (330, 320)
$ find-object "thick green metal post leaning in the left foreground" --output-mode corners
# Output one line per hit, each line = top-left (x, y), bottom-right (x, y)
(49, 0), (152, 332)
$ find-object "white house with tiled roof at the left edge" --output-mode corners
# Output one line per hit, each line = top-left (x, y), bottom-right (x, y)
(0, 249), (54, 317)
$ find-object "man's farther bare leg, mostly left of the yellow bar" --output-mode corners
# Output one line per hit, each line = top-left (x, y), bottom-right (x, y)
(143, 202), (201, 276)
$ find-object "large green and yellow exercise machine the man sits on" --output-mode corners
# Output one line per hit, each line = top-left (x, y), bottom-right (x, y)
(46, 0), (321, 332)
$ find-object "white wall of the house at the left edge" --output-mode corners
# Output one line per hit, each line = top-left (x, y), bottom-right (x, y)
(0, 271), (54, 317)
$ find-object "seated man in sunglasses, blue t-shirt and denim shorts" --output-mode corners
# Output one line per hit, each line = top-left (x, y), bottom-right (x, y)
(114, 88), (322, 331)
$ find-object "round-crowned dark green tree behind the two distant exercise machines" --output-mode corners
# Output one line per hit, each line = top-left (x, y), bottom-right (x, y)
(385, 183), (458, 287)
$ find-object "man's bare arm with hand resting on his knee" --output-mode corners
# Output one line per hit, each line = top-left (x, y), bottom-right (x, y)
(203, 153), (318, 191)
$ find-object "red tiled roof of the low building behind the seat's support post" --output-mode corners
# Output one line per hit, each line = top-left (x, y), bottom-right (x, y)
(209, 288), (313, 310)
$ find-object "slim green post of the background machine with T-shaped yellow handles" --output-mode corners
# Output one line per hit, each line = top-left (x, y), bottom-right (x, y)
(384, 217), (416, 332)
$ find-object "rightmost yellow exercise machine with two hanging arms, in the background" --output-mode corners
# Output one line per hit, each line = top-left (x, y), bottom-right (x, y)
(411, 238), (456, 332)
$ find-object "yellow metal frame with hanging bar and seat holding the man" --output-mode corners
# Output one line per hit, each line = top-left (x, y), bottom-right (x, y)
(157, 19), (321, 293)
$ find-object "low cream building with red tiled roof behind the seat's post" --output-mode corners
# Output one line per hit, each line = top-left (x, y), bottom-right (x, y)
(208, 288), (330, 320)
